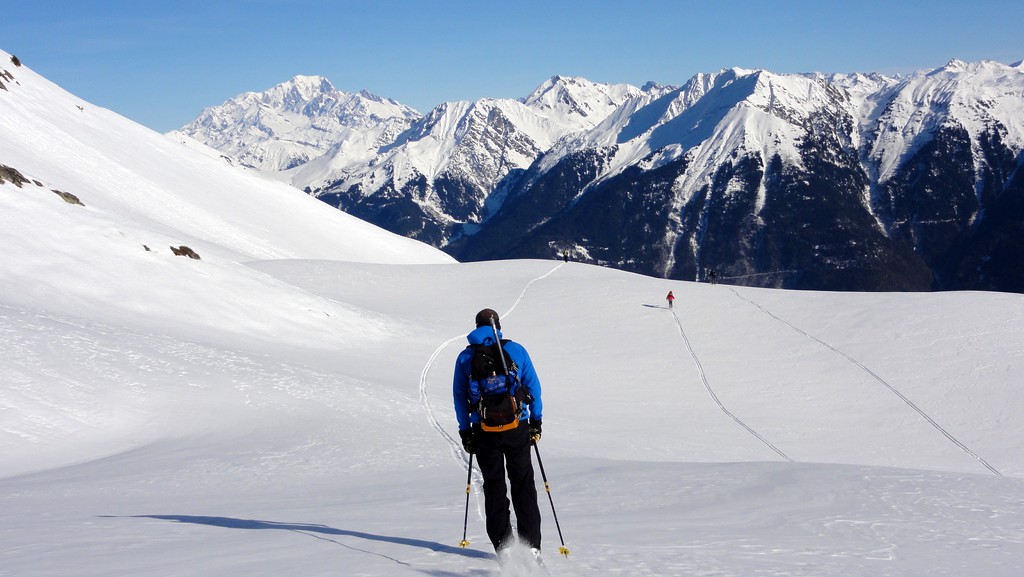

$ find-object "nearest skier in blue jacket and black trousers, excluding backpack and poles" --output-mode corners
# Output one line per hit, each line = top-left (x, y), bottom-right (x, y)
(453, 308), (544, 552)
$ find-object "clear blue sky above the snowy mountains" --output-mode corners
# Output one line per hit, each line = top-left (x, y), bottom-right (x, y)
(8, 0), (1024, 132)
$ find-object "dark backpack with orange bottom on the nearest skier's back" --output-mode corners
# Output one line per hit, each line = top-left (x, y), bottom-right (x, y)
(468, 339), (529, 432)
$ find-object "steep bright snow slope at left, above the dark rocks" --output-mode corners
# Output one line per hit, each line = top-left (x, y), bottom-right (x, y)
(0, 54), (451, 262)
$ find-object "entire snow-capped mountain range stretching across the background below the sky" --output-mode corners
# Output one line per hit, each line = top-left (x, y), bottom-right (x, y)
(182, 60), (1024, 291)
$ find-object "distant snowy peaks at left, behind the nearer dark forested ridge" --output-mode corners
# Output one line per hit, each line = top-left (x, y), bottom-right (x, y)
(178, 77), (669, 246)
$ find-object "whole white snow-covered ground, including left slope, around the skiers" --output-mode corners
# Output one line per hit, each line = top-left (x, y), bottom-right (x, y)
(0, 52), (1024, 577)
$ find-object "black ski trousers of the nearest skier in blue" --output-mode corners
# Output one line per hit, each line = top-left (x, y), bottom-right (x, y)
(473, 421), (541, 550)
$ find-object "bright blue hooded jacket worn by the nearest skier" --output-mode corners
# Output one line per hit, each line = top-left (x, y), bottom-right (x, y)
(452, 327), (544, 430)
